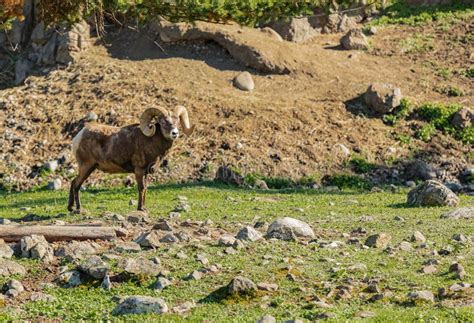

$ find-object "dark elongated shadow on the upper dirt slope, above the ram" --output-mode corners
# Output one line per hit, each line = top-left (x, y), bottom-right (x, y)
(105, 28), (246, 71)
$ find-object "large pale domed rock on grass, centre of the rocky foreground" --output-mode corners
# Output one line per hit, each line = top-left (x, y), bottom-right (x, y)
(267, 217), (314, 240)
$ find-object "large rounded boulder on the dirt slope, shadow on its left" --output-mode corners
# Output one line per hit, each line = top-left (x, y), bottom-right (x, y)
(364, 83), (402, 114)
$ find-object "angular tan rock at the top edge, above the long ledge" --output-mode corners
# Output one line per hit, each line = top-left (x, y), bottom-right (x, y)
(270, 17), (318, 43)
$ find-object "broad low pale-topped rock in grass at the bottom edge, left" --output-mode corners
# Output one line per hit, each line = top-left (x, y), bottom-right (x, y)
(112, 295), (168, 315)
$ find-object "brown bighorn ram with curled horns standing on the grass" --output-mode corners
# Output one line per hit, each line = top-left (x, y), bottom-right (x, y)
(68, 106), (194, 212)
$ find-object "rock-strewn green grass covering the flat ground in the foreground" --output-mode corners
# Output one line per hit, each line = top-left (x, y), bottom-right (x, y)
(0, 184), (474, 322)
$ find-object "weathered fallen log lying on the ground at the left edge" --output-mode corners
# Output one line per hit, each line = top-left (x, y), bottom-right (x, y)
(0, 225), (124, 242)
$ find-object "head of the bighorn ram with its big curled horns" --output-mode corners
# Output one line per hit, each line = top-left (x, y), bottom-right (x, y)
(140, 105), (194, 140)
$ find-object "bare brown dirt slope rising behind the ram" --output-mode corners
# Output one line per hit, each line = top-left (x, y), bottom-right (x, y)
(0, 19), (473, 188)
